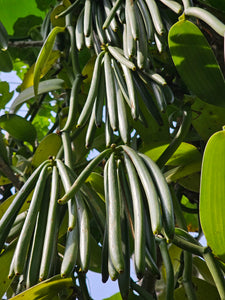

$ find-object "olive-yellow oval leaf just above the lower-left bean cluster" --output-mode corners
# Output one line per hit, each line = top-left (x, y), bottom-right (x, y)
(32, 133), (62, 167)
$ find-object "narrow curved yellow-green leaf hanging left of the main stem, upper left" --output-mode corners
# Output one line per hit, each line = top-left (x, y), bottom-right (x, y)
(34, 27), (65, 95)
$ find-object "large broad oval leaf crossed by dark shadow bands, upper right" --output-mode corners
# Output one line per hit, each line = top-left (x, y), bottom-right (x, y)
(168, 20), (225, 107)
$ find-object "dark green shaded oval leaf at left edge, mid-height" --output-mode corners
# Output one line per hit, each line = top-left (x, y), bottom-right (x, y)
(0, 114), (37, 144)
